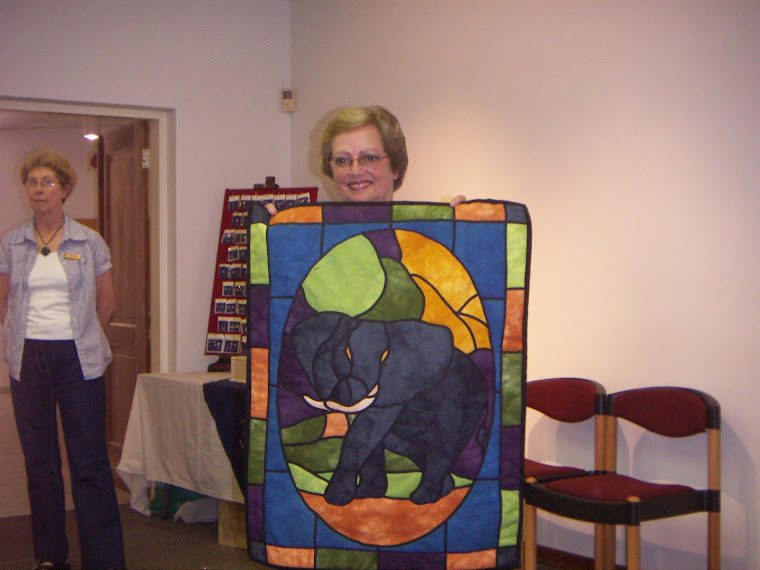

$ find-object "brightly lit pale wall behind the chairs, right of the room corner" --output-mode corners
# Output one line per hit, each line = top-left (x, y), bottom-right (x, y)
(292, 0), (760, 569)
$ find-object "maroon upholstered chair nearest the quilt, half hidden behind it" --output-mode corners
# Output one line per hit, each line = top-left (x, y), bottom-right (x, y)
(524, 378), (614, 570)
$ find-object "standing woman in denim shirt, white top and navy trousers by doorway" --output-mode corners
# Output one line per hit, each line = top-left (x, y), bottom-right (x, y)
(0, 149), (124, 570)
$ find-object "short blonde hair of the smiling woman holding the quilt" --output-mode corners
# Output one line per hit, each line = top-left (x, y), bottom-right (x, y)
(321, 105), (409, 191)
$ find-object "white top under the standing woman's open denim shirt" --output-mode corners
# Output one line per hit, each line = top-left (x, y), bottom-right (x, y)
(26, 252), (74, 340)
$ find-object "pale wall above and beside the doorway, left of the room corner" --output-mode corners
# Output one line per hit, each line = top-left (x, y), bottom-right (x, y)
(0, 0), (291, 370)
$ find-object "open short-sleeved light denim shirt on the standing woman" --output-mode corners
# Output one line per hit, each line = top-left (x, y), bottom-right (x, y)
(0, 216), (111, 380)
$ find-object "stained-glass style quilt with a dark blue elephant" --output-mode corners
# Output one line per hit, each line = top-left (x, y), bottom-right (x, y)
(246, 200), (531, 569)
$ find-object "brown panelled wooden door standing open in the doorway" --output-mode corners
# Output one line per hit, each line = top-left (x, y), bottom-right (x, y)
(99, 120), (150, 466)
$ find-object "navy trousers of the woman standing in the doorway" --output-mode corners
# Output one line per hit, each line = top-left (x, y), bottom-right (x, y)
(11, 339), (124, 570)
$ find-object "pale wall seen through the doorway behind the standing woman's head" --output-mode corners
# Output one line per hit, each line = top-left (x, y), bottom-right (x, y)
(0, 128), (98, 388)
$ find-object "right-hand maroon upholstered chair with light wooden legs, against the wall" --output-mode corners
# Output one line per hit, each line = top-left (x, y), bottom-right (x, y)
(525, 387), (720, 569)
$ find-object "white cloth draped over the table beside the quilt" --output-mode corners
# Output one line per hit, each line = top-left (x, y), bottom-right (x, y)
(116, 372), (243, 514)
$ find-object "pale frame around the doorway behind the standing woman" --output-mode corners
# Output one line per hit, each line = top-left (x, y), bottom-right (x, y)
(0, 96), (177, 372)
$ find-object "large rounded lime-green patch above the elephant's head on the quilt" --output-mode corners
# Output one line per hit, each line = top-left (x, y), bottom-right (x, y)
(303, 235), (385, 317)
